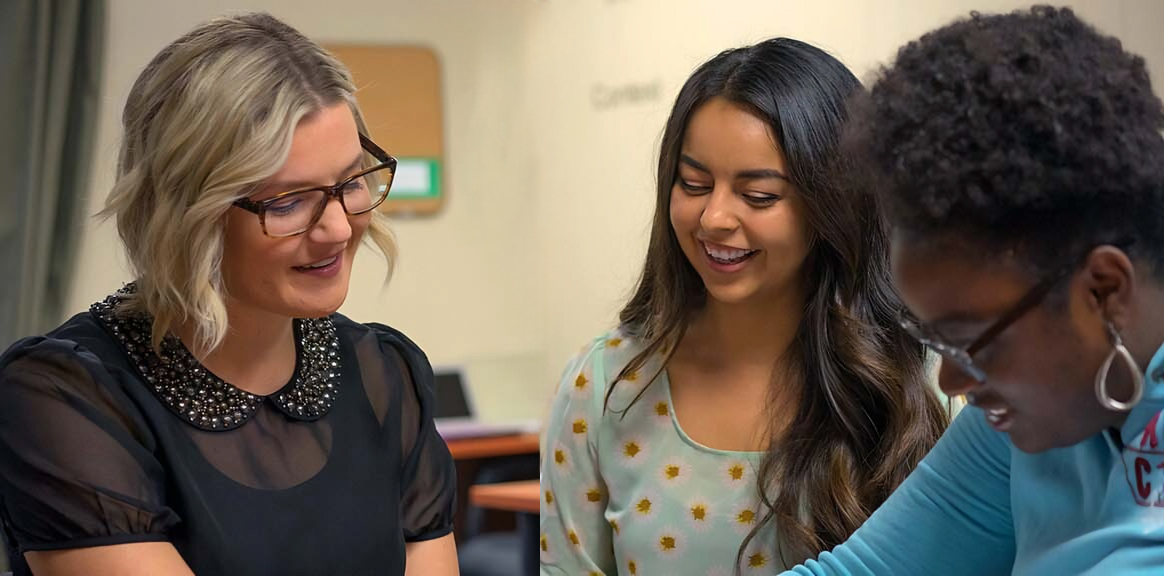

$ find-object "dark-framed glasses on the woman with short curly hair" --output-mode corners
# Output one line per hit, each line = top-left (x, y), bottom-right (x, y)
(900, 240), (1135, 383)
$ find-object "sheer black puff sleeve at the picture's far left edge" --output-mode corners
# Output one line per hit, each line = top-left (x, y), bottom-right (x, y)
(0, 337), (179, 555)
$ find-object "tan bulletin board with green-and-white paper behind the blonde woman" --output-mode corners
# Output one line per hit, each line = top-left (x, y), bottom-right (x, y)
(325, 44), (448, 214)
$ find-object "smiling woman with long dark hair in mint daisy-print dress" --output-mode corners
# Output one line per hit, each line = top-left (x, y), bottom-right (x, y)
(541, 38), (946, 576)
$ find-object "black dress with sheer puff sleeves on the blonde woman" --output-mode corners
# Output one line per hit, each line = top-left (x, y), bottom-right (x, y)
(0, 285), (456, 576)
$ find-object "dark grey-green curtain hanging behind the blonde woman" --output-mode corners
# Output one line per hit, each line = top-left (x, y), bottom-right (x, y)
(0, 0), (106, 570)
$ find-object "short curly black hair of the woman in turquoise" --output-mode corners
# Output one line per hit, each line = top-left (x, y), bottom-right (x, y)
(851, 6), (1164, 270)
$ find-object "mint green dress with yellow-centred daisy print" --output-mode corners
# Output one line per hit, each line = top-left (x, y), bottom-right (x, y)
(541, 330), (785, 576)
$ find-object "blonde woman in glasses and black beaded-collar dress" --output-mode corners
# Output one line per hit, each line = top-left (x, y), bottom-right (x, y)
(0, 14), (457, 576)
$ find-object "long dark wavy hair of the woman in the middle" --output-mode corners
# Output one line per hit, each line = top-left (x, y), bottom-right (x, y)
(606, 38), (949, 570)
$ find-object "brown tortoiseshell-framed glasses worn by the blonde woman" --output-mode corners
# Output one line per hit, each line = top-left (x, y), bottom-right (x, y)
(234, 134), (396, 237)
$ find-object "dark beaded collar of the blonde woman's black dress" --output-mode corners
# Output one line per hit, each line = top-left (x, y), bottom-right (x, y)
(90, 284), (340, 431)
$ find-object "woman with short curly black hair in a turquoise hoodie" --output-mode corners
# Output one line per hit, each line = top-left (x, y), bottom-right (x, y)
(789, 7), (1164, 576)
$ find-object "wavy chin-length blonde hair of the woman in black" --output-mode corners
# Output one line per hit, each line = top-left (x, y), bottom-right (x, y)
(100, 13), (396, 354)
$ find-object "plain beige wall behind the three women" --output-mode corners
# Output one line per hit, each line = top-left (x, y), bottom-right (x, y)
(71, 0), (1164, 419)
